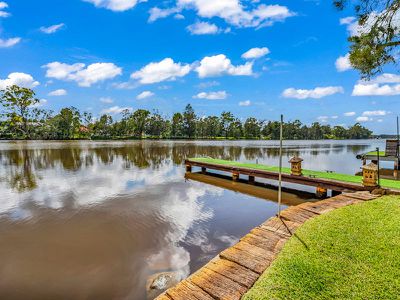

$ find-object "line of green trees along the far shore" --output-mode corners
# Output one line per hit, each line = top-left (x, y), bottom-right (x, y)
(0, 85), (372, 140)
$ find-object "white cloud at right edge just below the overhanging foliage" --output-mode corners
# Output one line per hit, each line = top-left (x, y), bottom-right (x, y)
(352, 73), (400, 96)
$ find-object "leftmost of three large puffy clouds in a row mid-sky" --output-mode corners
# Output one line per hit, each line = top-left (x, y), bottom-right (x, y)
(43, 62), (122, 87)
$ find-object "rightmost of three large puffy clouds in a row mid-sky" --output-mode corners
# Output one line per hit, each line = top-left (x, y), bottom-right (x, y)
(196, 54), (253, 78)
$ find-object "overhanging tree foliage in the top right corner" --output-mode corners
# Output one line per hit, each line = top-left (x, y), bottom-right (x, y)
(333, 0), (400, 79)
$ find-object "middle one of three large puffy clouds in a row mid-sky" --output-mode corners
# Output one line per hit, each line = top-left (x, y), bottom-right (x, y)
(131, 58), (191, 84)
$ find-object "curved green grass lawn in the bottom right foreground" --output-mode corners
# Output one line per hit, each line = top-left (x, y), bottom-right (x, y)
(244, 196), (400, 300)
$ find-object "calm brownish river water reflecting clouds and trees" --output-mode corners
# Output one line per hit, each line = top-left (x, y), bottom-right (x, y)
(0, 140), (384, 300)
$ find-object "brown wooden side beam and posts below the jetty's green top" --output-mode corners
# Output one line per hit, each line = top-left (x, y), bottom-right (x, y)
(185, 159), (367, 196)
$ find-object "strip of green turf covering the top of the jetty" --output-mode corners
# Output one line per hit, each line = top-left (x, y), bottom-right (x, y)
(190, 157), (400, 189)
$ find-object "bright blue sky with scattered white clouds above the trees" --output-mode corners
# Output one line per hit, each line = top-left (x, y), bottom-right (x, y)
(0, 0), (400, 133)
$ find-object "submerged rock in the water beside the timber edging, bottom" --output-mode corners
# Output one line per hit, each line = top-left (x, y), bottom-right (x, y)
(146, 272), (180, 299)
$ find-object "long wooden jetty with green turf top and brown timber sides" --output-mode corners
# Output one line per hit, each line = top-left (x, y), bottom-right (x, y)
(185, 158), (400, 192)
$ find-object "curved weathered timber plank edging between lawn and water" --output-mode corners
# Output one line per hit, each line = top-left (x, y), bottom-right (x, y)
(156, 192), (378, 300)
